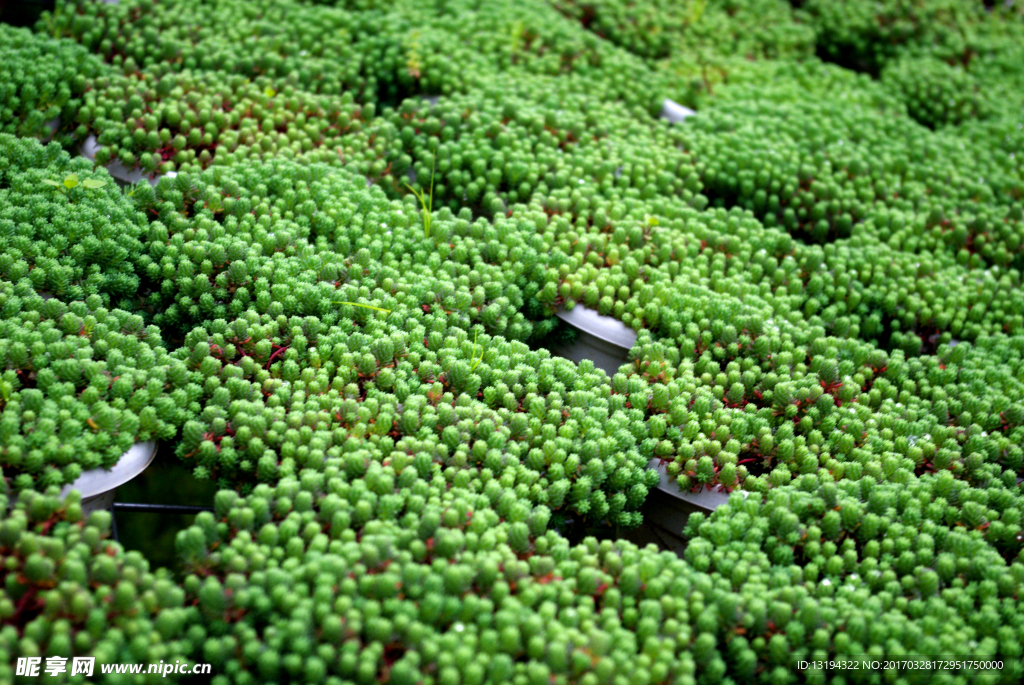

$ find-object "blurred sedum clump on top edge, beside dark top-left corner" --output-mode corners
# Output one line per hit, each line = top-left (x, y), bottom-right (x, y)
(41, 0), (382, 96)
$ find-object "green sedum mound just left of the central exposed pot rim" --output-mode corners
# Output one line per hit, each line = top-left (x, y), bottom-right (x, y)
(133, 156), (542, 340)
